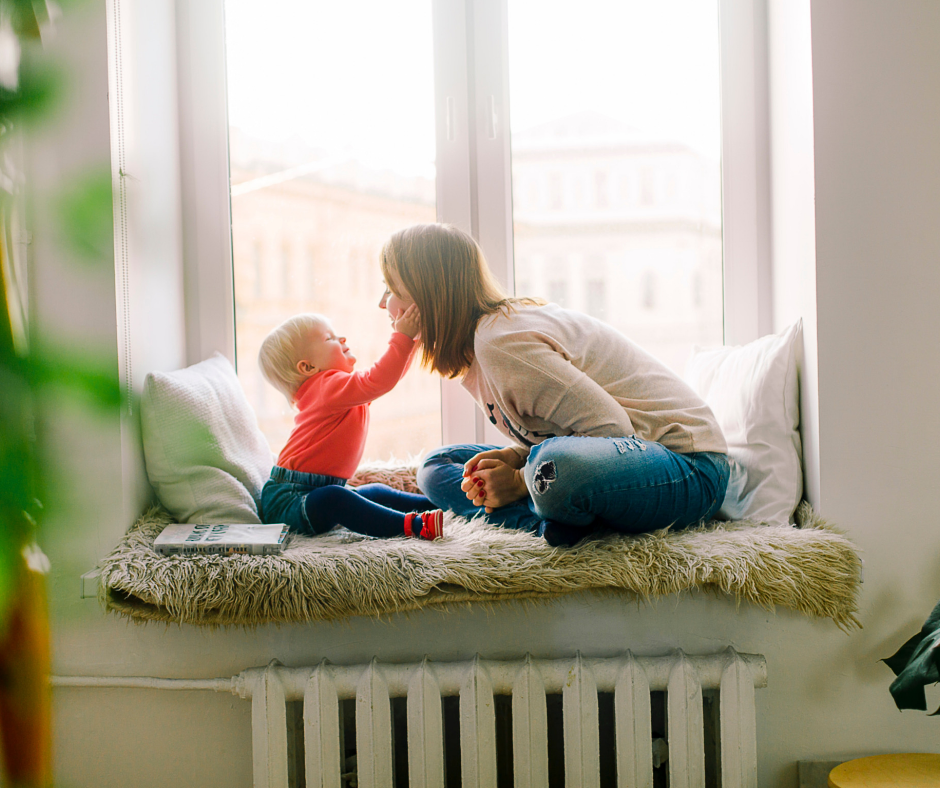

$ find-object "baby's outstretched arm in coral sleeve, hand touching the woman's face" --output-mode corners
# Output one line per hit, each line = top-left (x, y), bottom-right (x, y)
(321, 304), (420, 408)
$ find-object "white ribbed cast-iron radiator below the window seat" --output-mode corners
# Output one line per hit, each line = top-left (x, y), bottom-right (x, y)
(231, 648), (767, 788)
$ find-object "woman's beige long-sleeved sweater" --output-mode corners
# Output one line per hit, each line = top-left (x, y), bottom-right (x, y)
(462, 304), (728, 454)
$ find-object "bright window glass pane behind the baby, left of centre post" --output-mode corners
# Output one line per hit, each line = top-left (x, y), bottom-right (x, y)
(225, 0), (441, 459)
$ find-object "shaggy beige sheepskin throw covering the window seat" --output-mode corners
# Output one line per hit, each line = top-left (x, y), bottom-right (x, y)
(101, 467), (861, 630)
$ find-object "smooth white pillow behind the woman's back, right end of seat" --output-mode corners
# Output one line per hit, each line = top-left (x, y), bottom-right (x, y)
(685, 320), (803, 524)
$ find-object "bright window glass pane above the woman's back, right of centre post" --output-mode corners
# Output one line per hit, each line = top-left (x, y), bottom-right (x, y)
(509, 0), (723, 373)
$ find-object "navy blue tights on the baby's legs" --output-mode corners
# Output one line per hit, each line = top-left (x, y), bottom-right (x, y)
(304, 484), (435, 537)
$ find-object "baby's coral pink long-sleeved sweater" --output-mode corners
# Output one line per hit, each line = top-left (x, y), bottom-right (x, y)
(277, 331), (415, 479)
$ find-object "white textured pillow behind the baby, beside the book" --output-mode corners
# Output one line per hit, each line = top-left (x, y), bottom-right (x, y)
(140, 353), (274, 524)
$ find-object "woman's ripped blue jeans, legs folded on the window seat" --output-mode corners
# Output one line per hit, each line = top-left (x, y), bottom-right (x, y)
(418, 436), (730, 533)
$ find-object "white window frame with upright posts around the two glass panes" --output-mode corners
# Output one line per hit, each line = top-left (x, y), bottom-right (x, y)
(177, 0), (773, 444)
